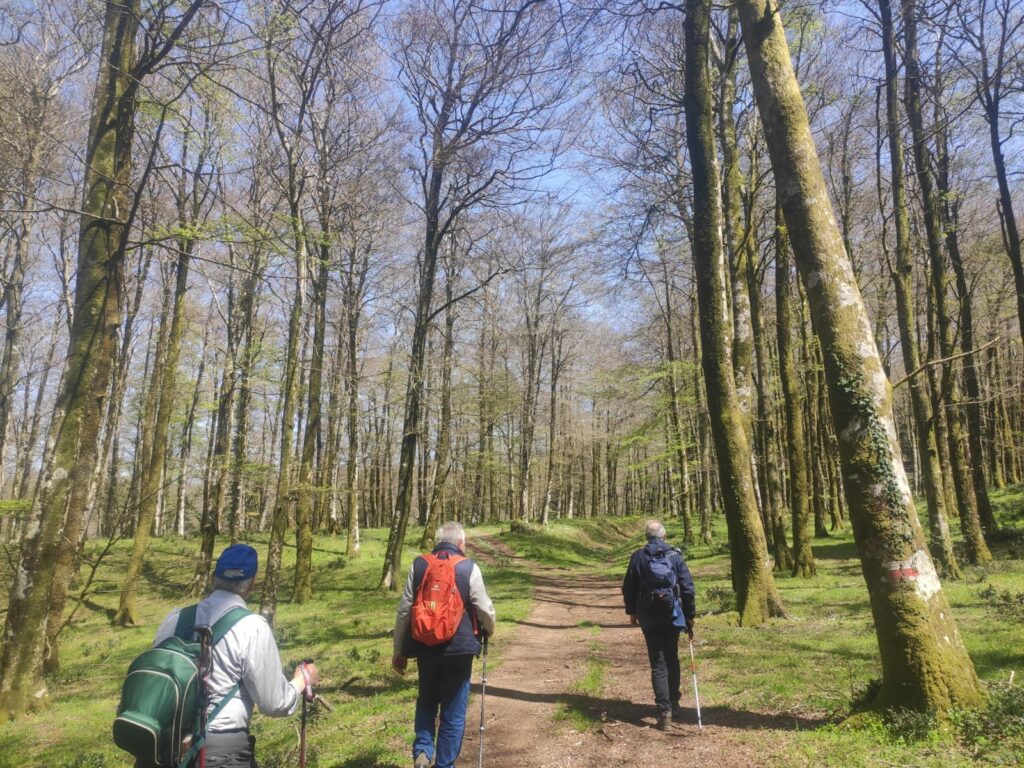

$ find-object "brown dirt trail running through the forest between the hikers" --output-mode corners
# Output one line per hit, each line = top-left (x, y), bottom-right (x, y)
(459, 537), (774, 768)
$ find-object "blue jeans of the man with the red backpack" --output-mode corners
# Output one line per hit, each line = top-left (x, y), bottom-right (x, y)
(413, 655), (473, 768)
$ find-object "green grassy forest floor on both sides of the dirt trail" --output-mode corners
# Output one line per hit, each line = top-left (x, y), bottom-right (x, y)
(0, 490), (1024, 768)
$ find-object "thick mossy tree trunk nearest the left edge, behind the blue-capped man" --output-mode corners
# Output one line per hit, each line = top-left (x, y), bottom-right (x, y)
(0, 0), (139, 721)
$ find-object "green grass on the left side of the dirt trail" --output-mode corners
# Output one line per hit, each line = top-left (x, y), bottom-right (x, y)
(0, 527), (531, 768)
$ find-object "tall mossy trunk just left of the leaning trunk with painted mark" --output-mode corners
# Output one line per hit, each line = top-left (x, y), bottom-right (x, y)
(683, 0), (783, 626)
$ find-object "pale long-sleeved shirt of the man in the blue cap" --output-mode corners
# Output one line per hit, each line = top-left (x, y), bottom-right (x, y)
(153, 590), (299, 732)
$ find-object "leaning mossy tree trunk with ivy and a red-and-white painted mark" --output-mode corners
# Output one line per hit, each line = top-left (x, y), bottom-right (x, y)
(738, 0), (982, 713)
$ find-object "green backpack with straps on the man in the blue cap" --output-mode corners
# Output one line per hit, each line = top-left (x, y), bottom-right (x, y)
(114, 605), (249, 768)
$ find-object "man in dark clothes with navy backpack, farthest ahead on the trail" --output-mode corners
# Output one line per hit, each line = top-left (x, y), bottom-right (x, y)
(623, 520), (696, 730)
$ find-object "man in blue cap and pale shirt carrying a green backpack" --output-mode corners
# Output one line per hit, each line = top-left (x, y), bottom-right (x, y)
(114, 544), (319, 768)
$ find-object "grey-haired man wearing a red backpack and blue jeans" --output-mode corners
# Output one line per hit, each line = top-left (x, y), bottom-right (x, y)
(391, 522), (495, 768)
